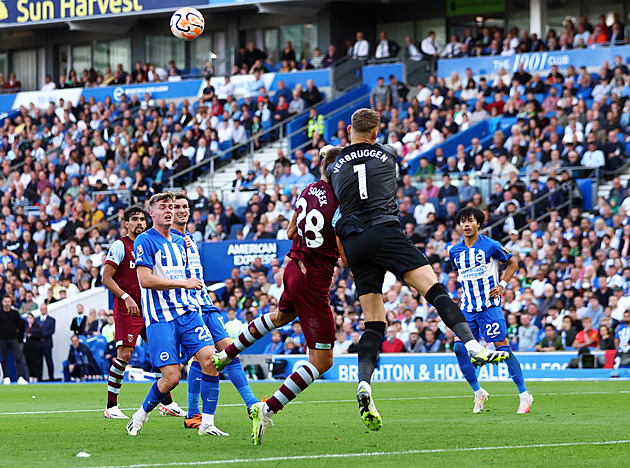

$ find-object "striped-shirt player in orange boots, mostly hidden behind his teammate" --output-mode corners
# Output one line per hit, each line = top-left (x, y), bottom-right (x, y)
(171, 193), (258, 428)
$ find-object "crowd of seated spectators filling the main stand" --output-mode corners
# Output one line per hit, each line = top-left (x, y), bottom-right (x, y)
(0, 13), (630, 384)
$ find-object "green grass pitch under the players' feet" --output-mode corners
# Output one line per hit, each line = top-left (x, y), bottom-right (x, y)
(0, 381), (630, 468)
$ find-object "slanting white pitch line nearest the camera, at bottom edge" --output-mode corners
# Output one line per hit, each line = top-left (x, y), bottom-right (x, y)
(78, 440), (630, 468)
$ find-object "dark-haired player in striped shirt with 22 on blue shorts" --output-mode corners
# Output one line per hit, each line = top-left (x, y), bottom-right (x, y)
(449, 207), (534, 413)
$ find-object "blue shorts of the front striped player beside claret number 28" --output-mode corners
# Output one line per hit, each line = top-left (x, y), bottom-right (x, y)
(147, 312), (212, 367)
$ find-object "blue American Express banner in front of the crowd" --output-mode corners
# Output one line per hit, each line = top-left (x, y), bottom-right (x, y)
(200, 239), (292, 282)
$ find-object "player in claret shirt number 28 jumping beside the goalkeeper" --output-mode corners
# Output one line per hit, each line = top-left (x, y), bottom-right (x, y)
(212, 146), (341, 445)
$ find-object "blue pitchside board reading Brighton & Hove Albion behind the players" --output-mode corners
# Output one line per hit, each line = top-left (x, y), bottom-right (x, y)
(274, 352), (624, 382)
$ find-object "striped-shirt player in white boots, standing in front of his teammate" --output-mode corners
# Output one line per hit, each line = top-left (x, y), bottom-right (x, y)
(127, 192), (229, 436)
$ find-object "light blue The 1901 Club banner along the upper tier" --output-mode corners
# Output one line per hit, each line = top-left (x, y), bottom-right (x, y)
(438, 46), (630, 78)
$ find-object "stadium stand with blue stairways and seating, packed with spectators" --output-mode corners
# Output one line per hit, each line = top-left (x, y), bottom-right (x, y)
(0, 11), (630, 384)
